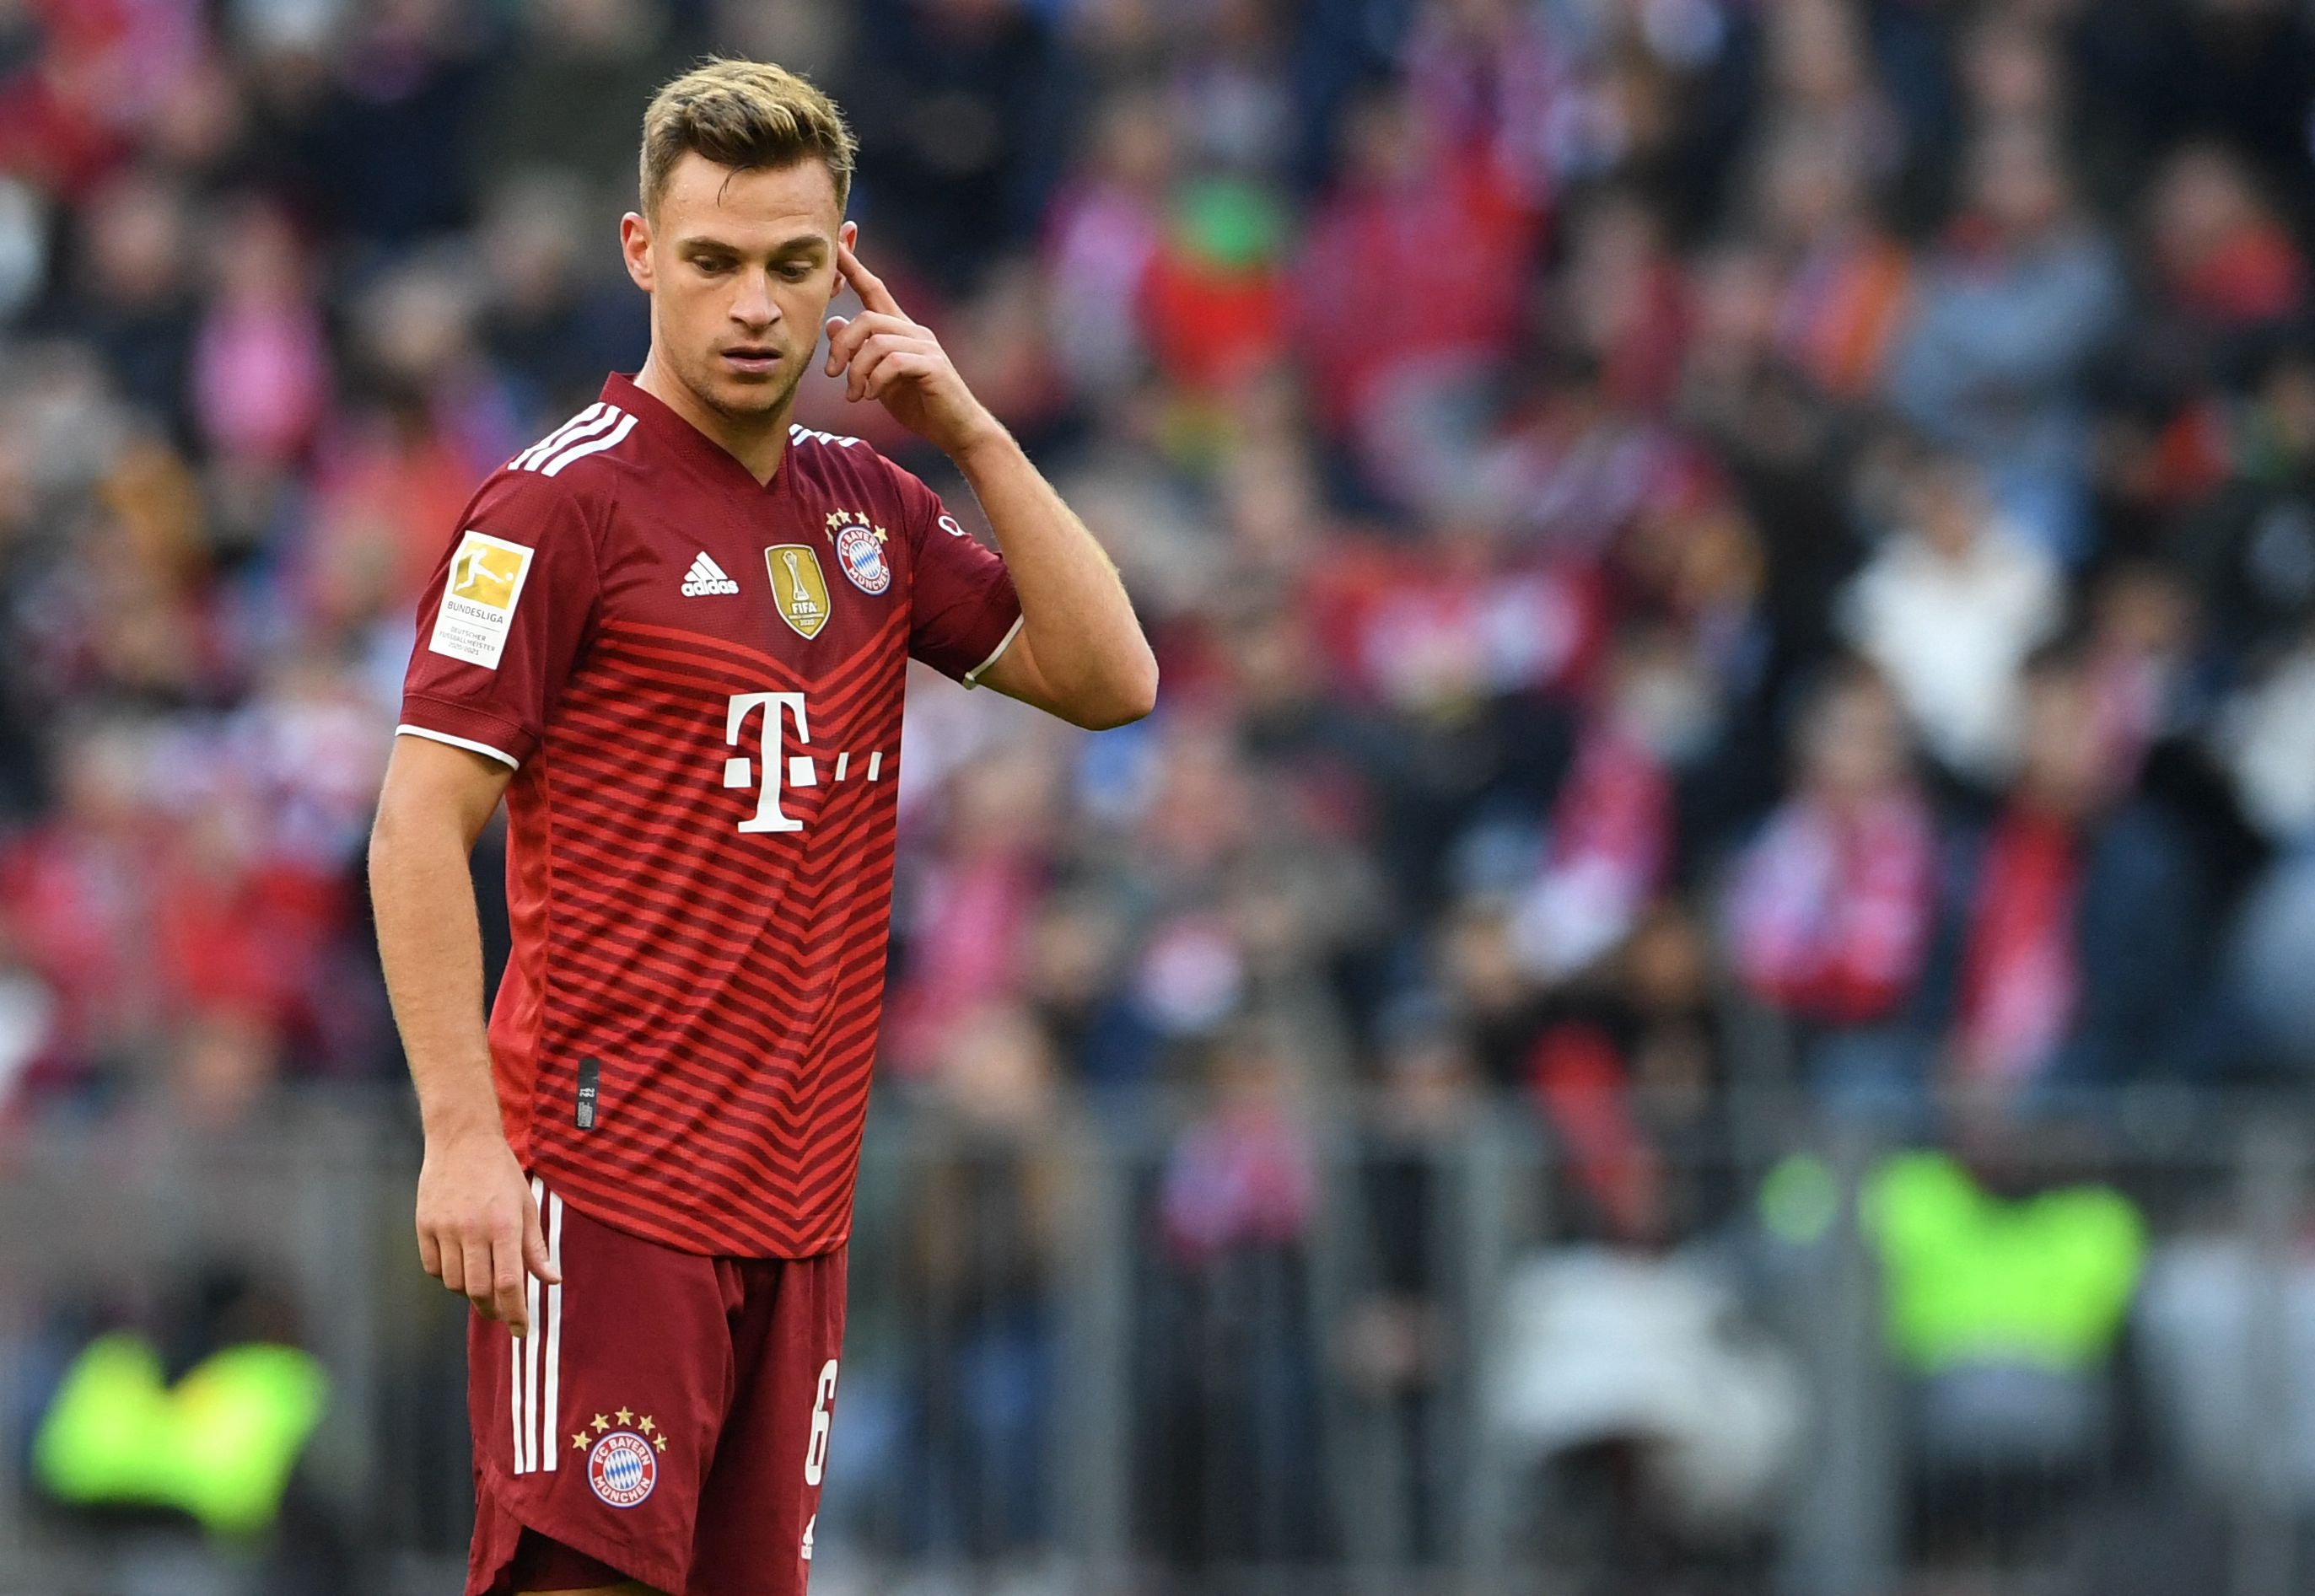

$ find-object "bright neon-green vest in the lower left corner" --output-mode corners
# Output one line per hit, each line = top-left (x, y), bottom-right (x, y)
(32, 1335), (329, 1534)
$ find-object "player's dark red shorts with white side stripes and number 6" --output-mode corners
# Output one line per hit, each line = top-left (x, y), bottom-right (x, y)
(466, 1180), (845, 1596)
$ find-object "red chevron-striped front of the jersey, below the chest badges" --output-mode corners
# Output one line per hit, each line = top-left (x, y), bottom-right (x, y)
(509, 610), (907, 1258)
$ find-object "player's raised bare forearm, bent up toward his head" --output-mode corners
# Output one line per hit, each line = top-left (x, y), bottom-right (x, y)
(956, 428), (1158, 726)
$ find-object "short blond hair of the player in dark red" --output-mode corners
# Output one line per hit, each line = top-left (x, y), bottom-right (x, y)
(643, 58), (859, 215)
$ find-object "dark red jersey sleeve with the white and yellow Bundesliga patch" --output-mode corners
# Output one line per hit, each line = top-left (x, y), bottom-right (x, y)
(396, 474), (602, 766)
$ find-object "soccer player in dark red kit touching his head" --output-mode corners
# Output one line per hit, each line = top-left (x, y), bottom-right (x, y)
(370, 60), (1158, 1596)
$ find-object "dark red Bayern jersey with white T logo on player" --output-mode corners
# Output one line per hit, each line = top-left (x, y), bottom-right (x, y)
(401, 377), (1021, 1258)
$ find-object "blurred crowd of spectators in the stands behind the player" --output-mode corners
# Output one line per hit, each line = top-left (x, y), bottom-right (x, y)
(0, 0), (2315, 1543)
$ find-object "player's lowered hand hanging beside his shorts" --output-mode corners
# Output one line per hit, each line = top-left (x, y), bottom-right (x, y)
(419, 1129), (563, 1335)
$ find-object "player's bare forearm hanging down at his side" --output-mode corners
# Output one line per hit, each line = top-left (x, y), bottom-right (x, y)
(370, 805), (500, 1141)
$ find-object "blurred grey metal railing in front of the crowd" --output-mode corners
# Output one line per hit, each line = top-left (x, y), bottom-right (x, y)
(0, 1092), (2315, 1596)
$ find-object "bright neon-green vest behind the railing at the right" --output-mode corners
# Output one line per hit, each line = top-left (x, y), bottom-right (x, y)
(1864, 1152), (2146, 1374)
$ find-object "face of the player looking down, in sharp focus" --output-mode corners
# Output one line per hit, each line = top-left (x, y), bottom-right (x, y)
(621, 155), (854, 419)
